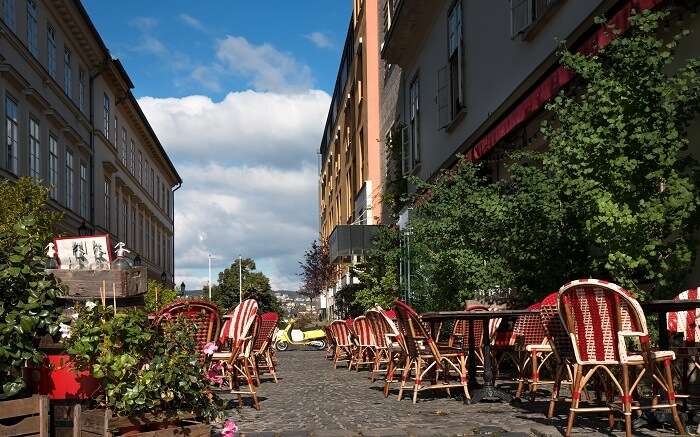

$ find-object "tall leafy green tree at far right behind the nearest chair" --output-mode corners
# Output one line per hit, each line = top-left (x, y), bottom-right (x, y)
(542, 11), (700, 297)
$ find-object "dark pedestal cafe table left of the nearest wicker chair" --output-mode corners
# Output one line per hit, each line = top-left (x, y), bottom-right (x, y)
(420, 310), (539, 403)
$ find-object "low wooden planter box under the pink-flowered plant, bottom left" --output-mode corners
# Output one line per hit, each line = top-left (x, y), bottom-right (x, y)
(73, 406), (211, 437)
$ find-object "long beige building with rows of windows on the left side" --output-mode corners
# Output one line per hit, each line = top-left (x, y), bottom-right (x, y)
(0, 0), (182, 282)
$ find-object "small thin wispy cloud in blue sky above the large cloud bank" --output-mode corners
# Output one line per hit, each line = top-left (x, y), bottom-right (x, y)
(216, 35), (313, 92)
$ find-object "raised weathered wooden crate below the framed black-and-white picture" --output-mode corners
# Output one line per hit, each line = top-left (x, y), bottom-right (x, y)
(48, 267), (148, 300)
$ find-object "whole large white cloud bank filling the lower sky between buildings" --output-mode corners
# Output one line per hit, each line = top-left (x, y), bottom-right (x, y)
(139, 90), (330, 289)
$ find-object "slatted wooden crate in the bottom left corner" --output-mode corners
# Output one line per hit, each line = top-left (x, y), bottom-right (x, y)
(0, 395), (49, 437)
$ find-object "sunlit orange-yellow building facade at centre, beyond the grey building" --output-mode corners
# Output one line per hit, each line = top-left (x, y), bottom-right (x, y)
(319, 0), (383, 315)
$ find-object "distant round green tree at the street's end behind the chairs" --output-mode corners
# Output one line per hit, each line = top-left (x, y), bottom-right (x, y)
(212, 258), (283, 314)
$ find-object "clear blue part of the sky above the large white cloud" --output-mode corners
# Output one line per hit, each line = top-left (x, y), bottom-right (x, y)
(84, 0), (351, 99)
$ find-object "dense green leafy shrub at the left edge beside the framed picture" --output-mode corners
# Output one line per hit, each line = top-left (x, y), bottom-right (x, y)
(0, 179), (62, 397)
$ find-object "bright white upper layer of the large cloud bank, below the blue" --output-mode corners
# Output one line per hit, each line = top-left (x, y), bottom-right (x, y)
(139, 90), (330, 167)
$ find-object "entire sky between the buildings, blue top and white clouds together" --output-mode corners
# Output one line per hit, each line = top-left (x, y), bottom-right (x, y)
(84, 0), (352, 289)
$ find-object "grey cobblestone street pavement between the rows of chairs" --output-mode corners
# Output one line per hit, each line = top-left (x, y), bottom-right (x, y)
(220, 350), (688, 436)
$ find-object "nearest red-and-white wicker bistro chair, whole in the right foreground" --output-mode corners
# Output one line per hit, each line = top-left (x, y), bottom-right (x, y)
(557, 279), (685, 436)
